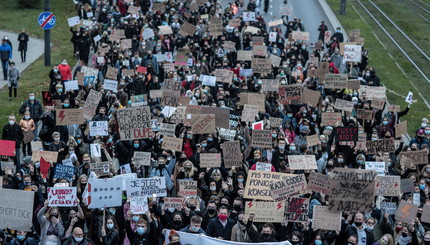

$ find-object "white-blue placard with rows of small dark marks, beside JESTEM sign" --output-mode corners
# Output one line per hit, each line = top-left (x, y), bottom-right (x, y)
(87, 178), (122, 208)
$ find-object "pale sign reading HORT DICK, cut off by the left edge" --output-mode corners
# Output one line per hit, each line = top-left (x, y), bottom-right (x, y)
(0, 189), (34, 231)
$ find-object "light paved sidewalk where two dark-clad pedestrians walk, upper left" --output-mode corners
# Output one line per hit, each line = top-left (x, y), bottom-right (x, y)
(0, 30), (45, 89)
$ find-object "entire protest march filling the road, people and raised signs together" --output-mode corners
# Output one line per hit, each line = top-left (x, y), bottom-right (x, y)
(0, 0), (430, 245)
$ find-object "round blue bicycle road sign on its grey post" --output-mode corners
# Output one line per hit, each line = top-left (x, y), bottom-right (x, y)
(37, 0), (56, 66)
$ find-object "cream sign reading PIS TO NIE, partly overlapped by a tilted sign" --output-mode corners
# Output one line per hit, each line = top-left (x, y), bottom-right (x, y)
(243, 170), (296, 201)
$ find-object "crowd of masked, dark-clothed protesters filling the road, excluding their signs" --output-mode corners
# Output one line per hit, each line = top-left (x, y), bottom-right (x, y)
(0, 0), (430, 245)
